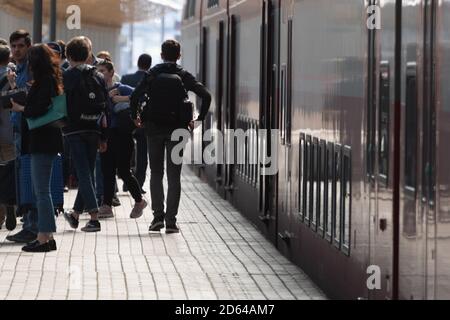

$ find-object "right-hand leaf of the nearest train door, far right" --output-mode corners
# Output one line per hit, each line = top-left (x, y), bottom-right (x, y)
(398, 0), (437, 299)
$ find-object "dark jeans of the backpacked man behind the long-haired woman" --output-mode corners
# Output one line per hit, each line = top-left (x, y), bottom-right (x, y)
(66, 133), (99, 213)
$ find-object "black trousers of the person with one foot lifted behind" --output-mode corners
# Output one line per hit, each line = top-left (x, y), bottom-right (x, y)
(101, 129), (142, 206)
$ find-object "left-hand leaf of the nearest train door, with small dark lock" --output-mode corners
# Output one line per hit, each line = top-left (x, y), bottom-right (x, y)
(366, 0), (399, 299)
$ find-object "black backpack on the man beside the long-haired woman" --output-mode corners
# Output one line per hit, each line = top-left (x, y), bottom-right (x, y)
(68, 66), (108, 127)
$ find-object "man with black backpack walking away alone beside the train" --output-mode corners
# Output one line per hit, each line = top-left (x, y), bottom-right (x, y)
(131, 40), (211, 233)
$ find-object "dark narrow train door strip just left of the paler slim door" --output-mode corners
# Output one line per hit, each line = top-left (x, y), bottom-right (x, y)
(260, 0), (280, 241)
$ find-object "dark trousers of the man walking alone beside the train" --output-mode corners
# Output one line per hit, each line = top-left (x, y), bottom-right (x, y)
(148, 134), (183, 226)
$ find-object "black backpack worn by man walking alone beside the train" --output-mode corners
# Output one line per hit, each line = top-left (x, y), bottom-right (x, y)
(145, 73), (193, 127)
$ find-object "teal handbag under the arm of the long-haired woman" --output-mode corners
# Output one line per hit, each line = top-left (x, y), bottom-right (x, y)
(27, 94), (67, 130)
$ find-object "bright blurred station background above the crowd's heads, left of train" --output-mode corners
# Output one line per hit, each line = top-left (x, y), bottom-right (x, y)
(0, 0), (184, 74)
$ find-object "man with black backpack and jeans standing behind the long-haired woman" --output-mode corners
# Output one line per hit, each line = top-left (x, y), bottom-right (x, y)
(64, 37), (109, 232)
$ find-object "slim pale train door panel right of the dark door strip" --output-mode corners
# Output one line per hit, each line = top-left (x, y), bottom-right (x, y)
(278, 1), (296, 252)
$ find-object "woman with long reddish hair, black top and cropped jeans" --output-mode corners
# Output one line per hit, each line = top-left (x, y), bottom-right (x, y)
(11, 44), (63, 252)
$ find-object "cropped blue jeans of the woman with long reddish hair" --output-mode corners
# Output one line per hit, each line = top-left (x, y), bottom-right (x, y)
(31, 153), (57, 233)
